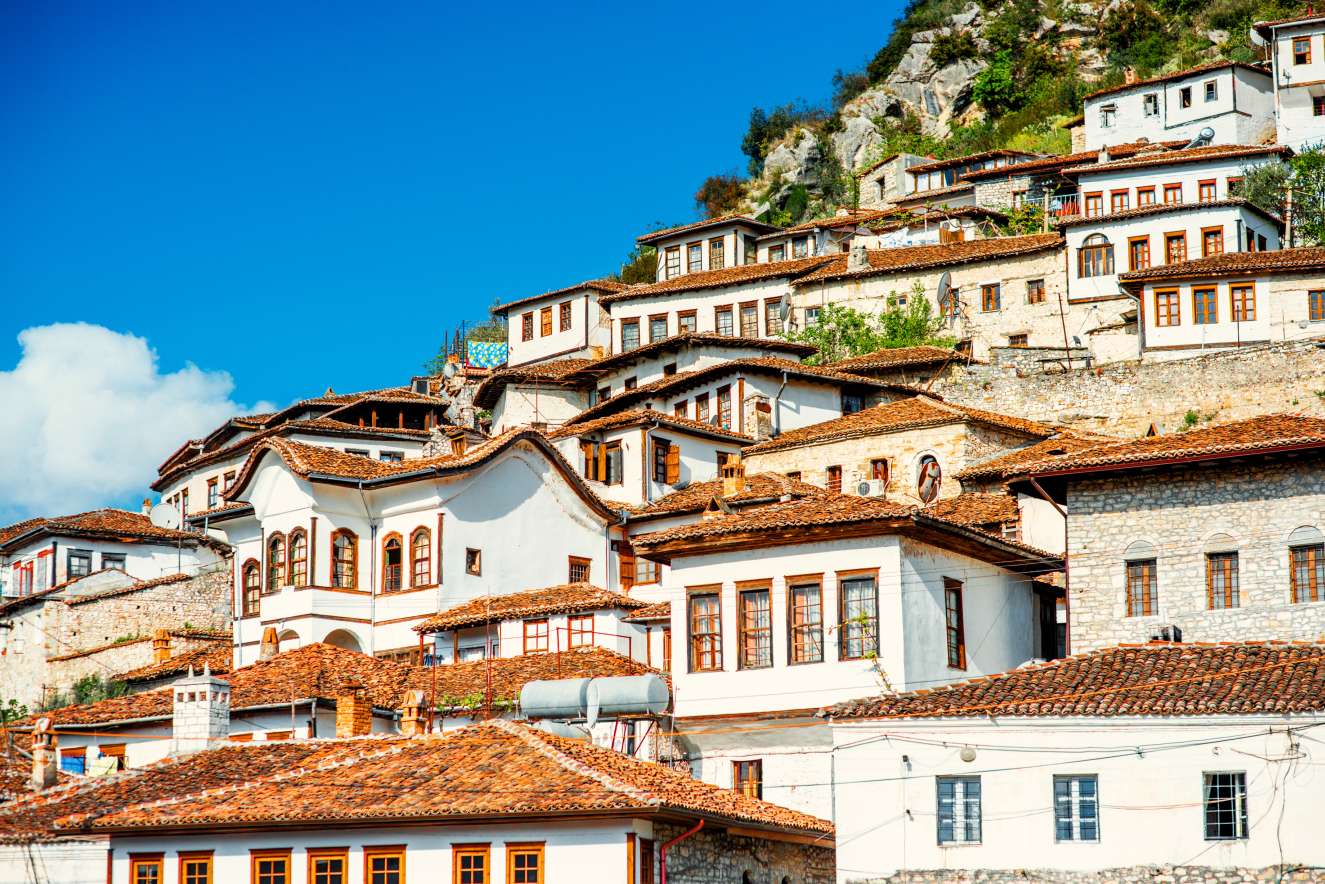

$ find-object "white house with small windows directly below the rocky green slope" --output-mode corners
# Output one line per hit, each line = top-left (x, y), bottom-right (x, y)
(1085, 61), (1283, 150)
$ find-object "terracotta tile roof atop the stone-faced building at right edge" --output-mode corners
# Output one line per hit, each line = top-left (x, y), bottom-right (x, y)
(1024, 415), (1325, 476)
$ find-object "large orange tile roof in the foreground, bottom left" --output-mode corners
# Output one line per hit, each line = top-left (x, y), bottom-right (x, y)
(25, 720), (833, 847)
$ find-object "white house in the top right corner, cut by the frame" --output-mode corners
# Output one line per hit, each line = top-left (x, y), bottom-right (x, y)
(1252, 8), (1325, 151)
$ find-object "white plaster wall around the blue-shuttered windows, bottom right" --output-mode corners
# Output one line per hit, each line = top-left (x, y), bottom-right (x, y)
(833, 716), (1325, 883)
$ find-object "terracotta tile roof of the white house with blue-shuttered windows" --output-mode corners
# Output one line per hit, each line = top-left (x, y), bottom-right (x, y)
(824, 641), (1325, 720)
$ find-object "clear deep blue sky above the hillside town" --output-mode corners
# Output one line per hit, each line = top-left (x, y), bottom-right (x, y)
(0, 0), (900, 519)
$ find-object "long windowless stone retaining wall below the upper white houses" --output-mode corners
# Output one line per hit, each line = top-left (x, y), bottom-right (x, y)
(931, 341), (1325, 436)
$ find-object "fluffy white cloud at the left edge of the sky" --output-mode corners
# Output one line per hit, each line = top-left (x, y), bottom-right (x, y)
(0, 322), (270, 524)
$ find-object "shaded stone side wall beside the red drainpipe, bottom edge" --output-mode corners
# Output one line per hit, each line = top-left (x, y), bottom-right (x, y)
(653, 823), (836, 884)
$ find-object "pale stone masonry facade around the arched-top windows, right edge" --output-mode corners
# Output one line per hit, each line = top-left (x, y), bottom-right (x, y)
(1067, 459), (1325, 652)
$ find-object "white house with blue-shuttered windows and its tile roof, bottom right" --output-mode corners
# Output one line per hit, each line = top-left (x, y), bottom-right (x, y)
(827, 640), (1325, 884)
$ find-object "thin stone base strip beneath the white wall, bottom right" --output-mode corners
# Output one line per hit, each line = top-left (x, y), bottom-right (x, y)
(847, 865), (1325, 884)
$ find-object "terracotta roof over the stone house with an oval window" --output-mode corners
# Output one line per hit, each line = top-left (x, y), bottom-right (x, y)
(745, 396), (1053, 456)
